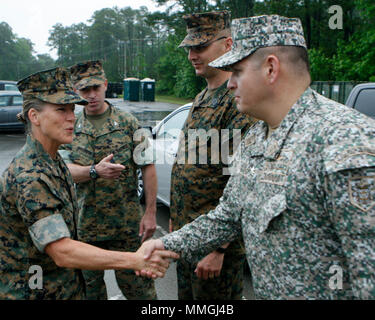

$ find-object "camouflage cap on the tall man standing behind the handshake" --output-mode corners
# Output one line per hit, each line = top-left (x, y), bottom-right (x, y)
(178, 11), (230, 48)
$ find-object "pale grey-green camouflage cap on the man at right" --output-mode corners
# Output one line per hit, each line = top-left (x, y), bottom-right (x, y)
(209, 15), (307, 70)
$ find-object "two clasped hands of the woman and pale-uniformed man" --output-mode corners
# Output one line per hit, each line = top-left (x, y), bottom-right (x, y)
(134, 239), (180, 279)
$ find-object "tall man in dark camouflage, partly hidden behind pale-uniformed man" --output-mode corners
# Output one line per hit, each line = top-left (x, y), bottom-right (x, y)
(170, 11), (254, 300)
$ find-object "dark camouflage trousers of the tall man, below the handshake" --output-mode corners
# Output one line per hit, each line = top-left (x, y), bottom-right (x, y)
(177, 248), (245, 300)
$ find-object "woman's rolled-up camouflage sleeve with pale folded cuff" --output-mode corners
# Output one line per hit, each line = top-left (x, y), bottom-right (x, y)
(16, 177), (71, 252)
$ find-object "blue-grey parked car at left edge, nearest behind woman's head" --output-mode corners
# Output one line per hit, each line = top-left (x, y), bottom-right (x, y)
(0, 91), (25, 130)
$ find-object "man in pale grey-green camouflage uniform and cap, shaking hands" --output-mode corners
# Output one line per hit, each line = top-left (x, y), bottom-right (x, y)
(142, 15), (375, 299)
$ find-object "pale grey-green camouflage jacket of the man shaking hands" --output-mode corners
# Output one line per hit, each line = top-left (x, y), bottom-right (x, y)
(162, 88), (375, 299)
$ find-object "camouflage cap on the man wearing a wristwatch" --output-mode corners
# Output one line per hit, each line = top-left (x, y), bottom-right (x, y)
(70, 60), (107, 90)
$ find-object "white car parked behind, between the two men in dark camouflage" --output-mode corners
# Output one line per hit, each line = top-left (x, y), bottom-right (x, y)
(138, 103), (192, 207)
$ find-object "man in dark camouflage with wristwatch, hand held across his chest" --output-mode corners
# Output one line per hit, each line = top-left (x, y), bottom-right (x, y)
(61, 61), (157, 300)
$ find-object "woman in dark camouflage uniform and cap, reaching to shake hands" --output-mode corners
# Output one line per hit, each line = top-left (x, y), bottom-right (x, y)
(0, 68), (176, 299)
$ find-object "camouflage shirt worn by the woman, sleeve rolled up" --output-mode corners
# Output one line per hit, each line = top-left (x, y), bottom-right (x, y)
(0, 136), (84, 300)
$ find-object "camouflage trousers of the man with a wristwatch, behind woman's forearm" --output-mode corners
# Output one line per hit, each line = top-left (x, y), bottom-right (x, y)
(83, 239), (157, 300)
